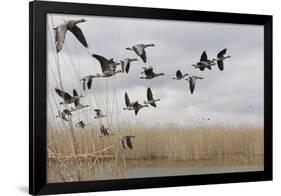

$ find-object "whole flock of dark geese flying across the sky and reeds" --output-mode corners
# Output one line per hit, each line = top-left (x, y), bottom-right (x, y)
(54, 19), (230, 149)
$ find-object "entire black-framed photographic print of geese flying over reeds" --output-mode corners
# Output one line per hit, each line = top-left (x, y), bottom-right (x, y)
(29, 1), (272, 194)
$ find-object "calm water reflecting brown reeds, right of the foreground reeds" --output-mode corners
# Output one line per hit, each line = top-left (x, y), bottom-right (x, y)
(94, 156), (264, 179)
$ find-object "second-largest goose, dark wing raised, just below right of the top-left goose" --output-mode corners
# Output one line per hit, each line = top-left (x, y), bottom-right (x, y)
(92, 54), (122, 77)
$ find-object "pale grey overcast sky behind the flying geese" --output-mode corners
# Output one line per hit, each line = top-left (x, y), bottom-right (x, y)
(47, 14), (264, 128)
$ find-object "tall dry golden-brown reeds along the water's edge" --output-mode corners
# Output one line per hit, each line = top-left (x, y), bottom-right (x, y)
(47, 124), (264, 182)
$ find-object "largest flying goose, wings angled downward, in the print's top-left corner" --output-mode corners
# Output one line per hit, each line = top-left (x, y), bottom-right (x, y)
(54, 19), (88, 52)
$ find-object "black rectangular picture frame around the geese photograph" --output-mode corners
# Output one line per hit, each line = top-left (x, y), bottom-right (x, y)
(29, 1), (273, 195)
